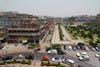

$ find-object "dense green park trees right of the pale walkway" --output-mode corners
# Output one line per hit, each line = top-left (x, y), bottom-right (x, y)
(66, 22), (100, 44)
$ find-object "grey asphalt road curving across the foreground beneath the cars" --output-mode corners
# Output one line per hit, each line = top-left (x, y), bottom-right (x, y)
(4, 52), (94, 67)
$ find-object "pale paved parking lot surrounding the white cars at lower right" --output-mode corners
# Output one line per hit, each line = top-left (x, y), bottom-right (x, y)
(62, 46), (100, 67)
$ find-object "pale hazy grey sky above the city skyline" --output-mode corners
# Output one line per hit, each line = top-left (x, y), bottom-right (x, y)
(0, 0), (100, 17)
